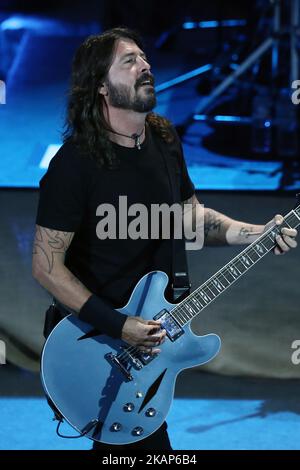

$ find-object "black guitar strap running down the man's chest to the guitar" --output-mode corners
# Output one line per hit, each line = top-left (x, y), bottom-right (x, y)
(153, 133), (191, 302)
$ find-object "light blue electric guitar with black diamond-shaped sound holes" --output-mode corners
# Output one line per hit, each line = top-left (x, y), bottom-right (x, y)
(41, 205), (300, 444)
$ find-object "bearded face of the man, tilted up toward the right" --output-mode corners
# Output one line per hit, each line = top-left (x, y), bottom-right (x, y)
(106, 39), (156, 113)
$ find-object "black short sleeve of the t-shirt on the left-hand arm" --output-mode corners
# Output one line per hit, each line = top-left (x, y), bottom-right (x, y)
(36, 143), (85, 232)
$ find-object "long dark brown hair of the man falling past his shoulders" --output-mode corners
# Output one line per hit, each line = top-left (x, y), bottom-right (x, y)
(63, 28), (173, 169)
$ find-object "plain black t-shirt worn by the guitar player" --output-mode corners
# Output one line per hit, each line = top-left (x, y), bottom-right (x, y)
(36, 126), (194, 308)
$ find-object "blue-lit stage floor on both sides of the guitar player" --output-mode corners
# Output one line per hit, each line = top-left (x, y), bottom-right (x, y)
(0, 365), (300, 450)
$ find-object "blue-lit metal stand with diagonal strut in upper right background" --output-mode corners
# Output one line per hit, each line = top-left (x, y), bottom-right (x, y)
(175, 0), (300, 179)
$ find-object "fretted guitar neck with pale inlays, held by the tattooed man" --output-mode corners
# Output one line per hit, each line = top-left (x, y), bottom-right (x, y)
(171, 205), (300, 326)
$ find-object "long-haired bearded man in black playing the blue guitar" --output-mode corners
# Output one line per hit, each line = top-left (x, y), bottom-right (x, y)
(33, 28), (297, 450)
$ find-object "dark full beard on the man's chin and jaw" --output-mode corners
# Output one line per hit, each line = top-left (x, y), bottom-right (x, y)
(107, 76), (156, 113)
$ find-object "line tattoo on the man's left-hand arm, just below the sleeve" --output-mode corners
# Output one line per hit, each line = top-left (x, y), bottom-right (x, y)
(33, 225), (74, 274)
